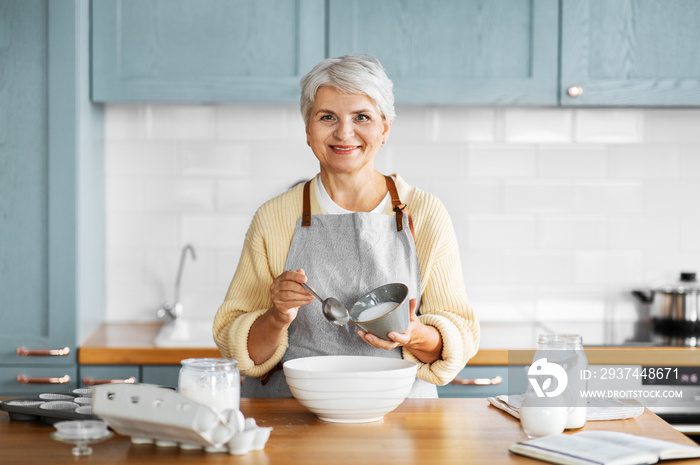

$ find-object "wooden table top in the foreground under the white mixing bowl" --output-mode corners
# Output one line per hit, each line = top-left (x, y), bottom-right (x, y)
(0, 399), (700, 465)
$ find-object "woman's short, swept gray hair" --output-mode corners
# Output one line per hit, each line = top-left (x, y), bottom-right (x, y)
(300, 54), (396, 126)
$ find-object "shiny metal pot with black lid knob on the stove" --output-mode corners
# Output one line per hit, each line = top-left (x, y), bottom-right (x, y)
(632, 272), (700, 347)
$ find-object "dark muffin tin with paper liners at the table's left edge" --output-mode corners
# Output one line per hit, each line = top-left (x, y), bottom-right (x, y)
(0, 388), (99, 425)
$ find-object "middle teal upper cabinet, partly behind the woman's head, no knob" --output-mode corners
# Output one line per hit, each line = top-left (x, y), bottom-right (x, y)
(328, 0), (559, 105)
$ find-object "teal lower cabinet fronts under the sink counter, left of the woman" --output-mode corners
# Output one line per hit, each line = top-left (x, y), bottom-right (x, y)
(80, 365), (180, 387)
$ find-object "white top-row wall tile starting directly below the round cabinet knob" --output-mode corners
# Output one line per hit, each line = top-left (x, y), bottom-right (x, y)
(574, 109), (645, 144)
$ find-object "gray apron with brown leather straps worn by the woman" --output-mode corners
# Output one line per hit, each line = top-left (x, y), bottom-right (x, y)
(241, 178), (437, 398)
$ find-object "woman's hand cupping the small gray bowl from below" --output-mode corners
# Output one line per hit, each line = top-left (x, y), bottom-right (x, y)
(357, 299), (442, 363)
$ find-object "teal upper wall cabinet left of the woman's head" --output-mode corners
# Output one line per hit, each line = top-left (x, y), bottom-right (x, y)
(92, 0), (325, 102)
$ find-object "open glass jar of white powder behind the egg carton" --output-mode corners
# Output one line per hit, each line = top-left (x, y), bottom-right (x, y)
(178, 358), (241, 412)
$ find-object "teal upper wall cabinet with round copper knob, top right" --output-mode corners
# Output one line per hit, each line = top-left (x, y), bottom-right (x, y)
(560, 0), (700, 106)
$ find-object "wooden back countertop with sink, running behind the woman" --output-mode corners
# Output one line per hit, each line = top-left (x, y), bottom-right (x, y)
(78, 322), (700, 366)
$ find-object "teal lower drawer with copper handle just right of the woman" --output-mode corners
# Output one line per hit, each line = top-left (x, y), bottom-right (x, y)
(437, 365), (527, 398)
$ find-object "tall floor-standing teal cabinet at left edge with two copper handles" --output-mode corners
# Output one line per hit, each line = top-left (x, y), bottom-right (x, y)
(0, 0), (104, 396)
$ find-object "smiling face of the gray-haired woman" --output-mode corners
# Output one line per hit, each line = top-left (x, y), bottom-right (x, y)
(306, 86), (391, 174)
